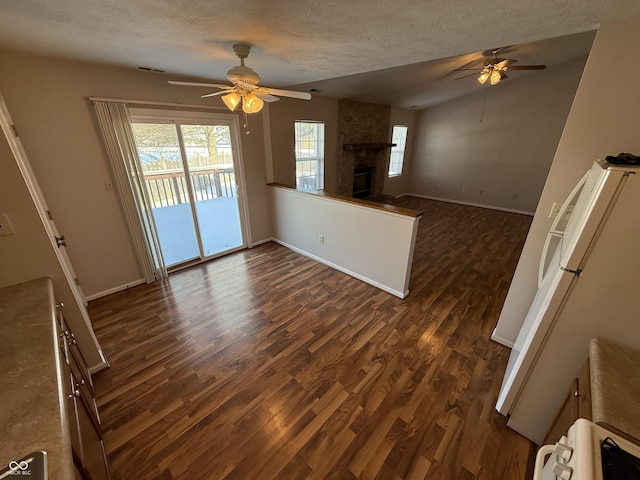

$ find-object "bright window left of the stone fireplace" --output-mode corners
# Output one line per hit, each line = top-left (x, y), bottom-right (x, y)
(295, 121), (324, 190)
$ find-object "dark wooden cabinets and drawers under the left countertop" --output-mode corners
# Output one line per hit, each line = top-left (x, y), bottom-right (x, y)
(57, 306), (110, 480)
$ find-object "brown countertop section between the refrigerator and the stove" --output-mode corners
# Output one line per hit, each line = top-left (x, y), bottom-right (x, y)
(589, 338), (640, 444)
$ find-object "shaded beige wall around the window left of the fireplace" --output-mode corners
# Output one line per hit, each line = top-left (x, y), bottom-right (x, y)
(269, 96), (338, 193)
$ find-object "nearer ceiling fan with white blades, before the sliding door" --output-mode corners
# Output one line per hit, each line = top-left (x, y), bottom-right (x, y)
(169, 44), (311, 113)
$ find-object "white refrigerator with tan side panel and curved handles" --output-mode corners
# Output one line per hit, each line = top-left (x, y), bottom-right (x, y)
(496, 161), (640, 445)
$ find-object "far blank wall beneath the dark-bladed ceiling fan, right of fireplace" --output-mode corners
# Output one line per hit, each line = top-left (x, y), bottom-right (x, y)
(405, 54), (585, 213)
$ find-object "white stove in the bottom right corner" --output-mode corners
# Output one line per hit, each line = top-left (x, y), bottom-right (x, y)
(533, 418), (640, 480)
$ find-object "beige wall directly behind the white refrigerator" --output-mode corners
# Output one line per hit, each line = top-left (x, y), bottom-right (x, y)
(492, 17), (640, 345)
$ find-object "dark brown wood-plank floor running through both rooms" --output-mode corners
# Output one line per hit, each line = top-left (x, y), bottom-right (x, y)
(89, 197), (534, 480)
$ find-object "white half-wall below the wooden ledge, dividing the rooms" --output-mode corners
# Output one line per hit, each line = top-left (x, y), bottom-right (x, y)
(270, 186), (418, 298)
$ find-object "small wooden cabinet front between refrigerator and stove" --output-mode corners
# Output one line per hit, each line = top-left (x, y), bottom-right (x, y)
(544, 359), (591, 445)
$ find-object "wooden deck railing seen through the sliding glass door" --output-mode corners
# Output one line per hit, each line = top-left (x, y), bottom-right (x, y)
(144, 165), (237, 208)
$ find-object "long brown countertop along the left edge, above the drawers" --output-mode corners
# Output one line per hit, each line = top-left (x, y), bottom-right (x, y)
(0, 277), (74, 480)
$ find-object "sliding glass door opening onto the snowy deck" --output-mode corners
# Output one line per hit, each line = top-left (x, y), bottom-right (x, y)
(131, 109), (246, 268)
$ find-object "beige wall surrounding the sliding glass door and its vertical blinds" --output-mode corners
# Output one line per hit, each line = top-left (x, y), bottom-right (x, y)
(0, 50), (271, 296)
